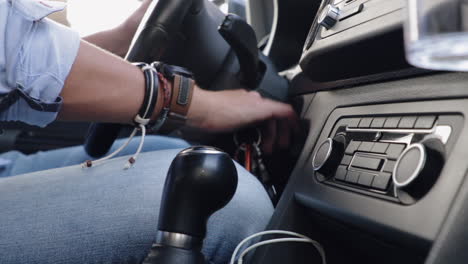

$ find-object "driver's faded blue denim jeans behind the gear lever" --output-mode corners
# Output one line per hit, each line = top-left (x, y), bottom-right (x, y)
(0, 137), (273, 264)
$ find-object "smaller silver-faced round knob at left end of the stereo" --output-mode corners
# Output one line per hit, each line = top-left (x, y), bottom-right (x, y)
(312, 135), (346, 177)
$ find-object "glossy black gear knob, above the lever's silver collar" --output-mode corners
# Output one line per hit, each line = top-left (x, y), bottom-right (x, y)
(158, 147), (237, 239)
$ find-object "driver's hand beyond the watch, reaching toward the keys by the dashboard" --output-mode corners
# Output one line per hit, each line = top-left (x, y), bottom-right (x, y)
(187, 87), (299, 153)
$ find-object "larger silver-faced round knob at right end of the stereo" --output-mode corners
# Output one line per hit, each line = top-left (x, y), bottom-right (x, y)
(392, 138), (445, 199)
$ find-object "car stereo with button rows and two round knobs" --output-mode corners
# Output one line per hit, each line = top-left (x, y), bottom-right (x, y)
(312, 115), (457, 204)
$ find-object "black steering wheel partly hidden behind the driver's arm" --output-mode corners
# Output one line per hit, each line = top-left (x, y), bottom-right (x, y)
(85, 0), (287, 157)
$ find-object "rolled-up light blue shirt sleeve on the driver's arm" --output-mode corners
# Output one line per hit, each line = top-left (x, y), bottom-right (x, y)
(0, 0), (80, 127)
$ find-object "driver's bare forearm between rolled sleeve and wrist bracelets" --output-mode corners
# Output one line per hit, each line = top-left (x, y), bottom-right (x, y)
(59, 41), (145, 123)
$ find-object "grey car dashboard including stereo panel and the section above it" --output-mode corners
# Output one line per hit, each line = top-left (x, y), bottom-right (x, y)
(252, 0), (468, 263)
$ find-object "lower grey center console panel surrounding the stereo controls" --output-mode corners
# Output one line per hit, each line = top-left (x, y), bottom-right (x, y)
(253, 73), (468, 263)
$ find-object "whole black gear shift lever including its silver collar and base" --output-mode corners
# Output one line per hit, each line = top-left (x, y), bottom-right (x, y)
(143, 147), (237, 264)
